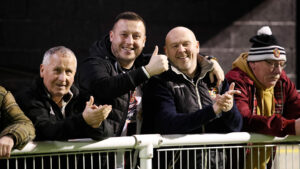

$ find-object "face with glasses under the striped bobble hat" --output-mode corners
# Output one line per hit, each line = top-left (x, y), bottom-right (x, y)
(249, 60), (285, 88)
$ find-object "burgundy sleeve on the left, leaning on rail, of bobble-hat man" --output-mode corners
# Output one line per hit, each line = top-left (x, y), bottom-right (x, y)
(226, 72), (295, 137)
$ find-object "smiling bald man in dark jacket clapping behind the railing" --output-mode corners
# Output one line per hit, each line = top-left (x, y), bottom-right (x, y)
(142, 27), (242, 167)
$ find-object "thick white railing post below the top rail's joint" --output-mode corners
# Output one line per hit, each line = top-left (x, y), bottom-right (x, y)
(139, 144), (153, 169)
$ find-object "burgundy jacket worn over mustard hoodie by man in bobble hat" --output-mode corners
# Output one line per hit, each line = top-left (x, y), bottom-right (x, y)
(226, 68), (300, 137)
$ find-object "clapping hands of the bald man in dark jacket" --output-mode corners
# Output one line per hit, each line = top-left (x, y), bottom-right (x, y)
(213, 83), (241, 114)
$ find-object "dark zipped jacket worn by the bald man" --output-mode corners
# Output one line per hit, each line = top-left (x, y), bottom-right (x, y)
(142, 63), (242, 134)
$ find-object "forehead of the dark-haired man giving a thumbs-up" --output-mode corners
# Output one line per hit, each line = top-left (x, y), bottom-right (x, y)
(113, 19), (146, 34)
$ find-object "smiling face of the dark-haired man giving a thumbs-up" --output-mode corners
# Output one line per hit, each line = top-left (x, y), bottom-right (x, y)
(109, 19), (146, 69)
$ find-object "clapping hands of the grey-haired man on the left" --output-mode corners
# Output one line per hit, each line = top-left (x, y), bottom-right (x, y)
(82, 96), (112, 128)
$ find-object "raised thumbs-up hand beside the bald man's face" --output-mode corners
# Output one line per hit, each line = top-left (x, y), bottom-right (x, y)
(145, 46), (169, 77)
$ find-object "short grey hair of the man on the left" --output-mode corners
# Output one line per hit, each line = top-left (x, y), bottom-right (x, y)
(42, 46), (77, 65)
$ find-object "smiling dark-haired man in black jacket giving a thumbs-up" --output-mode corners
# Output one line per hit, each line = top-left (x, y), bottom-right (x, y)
(79, 12), (223, 137)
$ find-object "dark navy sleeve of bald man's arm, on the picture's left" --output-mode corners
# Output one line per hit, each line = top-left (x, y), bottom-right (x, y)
(143, 78), (216, 134)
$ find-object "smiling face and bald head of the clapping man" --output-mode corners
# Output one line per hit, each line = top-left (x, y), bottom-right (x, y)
(165, 27), (199, 77)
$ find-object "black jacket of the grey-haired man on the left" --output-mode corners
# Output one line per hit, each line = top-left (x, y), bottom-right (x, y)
(16, 78), (102, 140)
